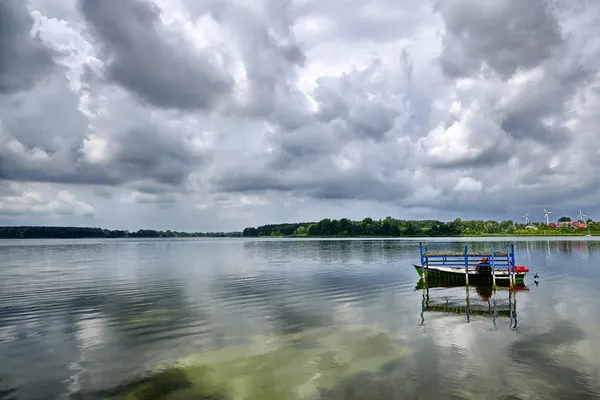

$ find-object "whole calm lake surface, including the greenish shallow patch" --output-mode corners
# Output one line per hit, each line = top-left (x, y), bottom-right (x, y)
(0, 238), (600, 400)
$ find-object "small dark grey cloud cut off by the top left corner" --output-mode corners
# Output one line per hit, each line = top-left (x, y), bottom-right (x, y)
(0, 0), (54, 94)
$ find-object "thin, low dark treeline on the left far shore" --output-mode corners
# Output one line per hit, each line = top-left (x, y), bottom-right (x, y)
(0, 226), (242, 239)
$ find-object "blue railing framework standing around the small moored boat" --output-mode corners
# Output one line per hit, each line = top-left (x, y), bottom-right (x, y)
(419, 242), (515, 287)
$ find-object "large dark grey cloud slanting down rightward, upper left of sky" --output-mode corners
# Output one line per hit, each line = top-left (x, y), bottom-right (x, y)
(78, 0), (234, 110)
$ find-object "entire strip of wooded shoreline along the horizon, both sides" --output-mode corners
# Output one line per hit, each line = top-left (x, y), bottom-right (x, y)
(0, 217), (600, 239)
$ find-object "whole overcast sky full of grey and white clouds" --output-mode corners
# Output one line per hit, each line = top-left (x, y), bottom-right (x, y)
(0, 0), (600, 231)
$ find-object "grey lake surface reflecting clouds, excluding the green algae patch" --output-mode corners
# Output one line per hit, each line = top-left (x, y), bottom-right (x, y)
(0, 240), (600, 399)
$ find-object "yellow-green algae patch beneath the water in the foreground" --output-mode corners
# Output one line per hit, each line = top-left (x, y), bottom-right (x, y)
(109, 327), (404, 400)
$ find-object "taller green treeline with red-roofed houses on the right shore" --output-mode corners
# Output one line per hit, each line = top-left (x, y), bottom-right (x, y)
(242, 217), (600, 237)
